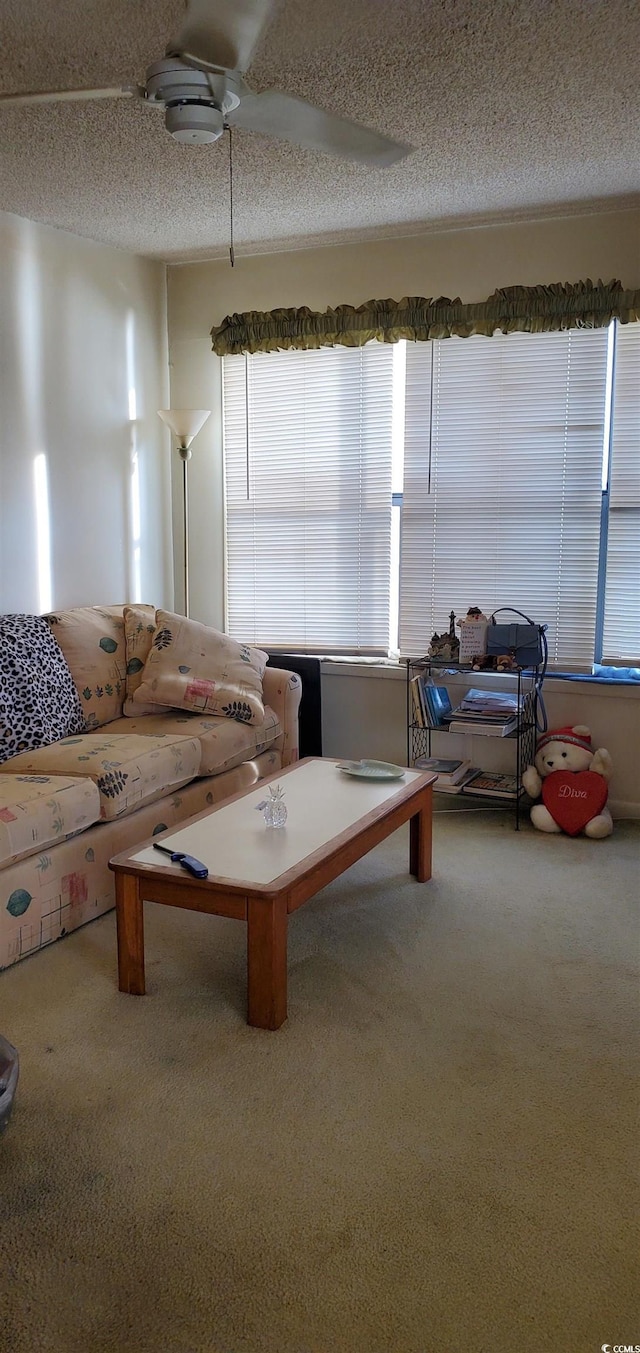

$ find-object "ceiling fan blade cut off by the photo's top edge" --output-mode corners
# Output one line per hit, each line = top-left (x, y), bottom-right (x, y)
(166, 0), (273, 73)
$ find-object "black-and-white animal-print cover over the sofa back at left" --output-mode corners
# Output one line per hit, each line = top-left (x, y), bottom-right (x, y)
(0, 614), (84, 762)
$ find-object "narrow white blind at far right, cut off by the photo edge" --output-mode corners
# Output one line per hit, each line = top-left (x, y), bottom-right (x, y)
(602, 325), (640, 663)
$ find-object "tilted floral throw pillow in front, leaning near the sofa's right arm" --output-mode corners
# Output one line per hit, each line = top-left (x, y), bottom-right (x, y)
(131, 610), (267, 724)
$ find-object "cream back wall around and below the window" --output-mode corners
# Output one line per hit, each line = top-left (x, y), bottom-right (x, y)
(168, 210), (640, 816)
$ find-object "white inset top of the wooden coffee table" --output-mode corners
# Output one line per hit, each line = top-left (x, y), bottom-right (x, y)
(131, 759), (424, 885)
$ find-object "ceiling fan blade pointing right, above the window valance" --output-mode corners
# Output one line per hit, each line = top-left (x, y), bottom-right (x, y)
(227, 89), (413, 166)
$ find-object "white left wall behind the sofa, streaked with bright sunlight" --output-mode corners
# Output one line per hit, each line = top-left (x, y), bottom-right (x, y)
(0, 212), (173, 612)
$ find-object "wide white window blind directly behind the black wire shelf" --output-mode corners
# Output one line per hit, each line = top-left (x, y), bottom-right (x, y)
(401, 329), (608, 667)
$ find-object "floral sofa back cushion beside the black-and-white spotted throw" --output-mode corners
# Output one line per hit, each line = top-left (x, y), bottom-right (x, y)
(45, 606), (126, 728)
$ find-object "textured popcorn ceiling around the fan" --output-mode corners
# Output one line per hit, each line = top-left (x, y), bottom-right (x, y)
(0, 0), (640, 260)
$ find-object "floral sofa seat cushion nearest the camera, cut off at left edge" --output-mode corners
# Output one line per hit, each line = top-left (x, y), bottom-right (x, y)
(0, 774), (100, 869)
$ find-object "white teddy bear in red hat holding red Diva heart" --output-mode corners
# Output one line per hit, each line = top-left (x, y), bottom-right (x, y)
(522, 724), (613, 839)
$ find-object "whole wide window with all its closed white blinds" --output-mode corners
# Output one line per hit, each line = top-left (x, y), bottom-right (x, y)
(223, 323), (640, 670)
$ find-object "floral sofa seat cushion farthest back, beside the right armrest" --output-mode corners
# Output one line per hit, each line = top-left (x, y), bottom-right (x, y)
(104, 705), (281, 775)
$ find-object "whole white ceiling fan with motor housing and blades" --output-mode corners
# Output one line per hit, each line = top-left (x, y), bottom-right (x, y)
(0, 0), (411, 166)
